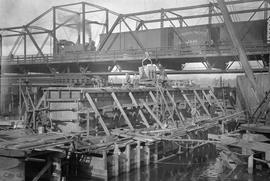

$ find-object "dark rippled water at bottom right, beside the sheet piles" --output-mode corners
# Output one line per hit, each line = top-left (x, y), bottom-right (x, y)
(72, 145), (270, 181)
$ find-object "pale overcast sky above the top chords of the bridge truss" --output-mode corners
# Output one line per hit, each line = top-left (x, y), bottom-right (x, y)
(0, 0), (209, 28)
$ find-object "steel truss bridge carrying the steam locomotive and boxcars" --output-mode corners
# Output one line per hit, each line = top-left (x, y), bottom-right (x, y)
(0, 0), (270, 74)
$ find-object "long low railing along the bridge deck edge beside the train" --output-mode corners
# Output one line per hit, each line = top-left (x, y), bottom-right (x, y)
(2, 43), (270, 64)
